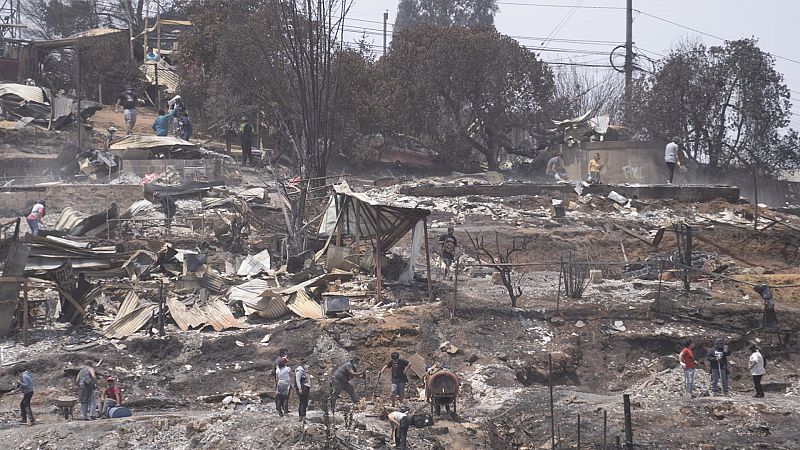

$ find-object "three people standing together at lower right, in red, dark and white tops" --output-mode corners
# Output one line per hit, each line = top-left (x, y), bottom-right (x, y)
(678, 338), (766, 398)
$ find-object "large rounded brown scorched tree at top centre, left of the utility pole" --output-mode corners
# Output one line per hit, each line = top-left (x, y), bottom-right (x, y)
(378, 26), (555, 170)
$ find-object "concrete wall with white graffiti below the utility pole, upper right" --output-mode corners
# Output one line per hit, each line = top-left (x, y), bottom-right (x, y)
(560, 141), (664, 184)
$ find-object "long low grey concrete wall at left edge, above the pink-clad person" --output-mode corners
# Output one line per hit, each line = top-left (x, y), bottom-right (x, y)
(0, 184), (143, 217)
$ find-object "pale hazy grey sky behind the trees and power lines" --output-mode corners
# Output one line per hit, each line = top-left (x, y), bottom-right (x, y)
(346, 0), (800, 129)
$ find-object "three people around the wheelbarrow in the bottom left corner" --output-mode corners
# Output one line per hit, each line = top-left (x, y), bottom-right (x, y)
(14, 361), (123, 425)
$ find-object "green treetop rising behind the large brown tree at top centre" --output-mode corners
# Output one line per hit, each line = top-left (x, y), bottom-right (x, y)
(394, 0), (498, 31)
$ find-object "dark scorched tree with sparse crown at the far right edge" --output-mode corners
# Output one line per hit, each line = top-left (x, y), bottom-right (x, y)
(634, 39), (800, 171)
